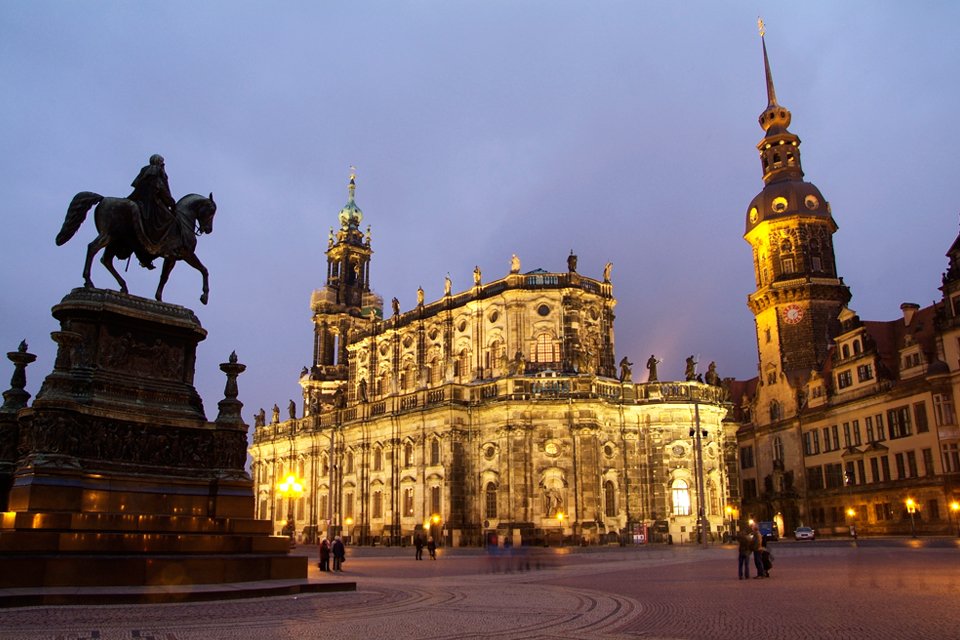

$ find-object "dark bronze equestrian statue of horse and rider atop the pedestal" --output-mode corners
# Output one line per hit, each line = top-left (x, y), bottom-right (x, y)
(57, 154), (217, 304)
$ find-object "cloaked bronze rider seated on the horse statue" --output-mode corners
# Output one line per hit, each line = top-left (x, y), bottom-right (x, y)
(130, 153), (177, 269)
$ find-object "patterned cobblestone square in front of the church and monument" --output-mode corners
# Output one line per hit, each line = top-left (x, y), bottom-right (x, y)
(0, 543), (960, 640)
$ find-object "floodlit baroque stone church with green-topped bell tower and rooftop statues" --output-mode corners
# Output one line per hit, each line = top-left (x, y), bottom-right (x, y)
(250, 176), (738, 545)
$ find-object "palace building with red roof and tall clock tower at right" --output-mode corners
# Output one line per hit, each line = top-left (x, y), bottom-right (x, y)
(731, 32), (960, 535)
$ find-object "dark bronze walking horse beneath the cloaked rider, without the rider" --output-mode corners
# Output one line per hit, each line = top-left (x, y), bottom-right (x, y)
(57, 191), (217, 304)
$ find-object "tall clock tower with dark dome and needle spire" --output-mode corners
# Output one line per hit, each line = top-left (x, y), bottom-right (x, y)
(744, 22), (850, 410)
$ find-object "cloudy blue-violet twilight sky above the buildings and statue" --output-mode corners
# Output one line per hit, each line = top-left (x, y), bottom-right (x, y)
(0, 5), (960, 424)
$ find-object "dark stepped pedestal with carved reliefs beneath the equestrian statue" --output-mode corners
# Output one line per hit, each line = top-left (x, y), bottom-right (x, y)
(0, 289), (307, 588)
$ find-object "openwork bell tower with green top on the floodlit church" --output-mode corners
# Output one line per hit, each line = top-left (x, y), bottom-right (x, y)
(300, 172), (383, 413)
